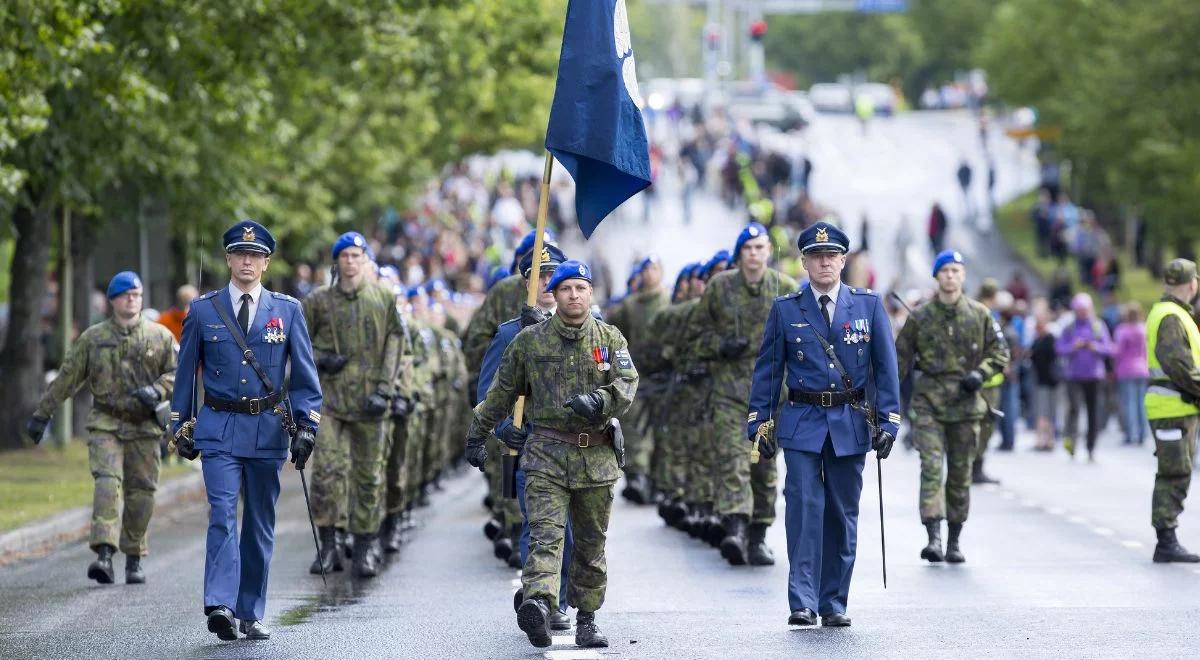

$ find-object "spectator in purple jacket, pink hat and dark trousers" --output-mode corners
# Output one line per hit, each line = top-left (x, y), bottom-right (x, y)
(1055, 293), (1112, 461)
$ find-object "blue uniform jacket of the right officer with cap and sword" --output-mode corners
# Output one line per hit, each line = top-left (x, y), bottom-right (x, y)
(746, 284), (900, 456)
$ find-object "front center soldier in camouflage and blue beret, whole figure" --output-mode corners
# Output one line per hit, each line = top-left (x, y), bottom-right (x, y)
(466, 260), (637, 648)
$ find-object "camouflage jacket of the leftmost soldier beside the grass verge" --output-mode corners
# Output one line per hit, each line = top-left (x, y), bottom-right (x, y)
(35, 318), (179, 437)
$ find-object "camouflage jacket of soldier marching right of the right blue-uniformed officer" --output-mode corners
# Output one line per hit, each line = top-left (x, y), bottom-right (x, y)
(896, 295), (1009, 422)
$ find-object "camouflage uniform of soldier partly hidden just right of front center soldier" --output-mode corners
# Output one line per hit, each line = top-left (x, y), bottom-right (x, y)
(605, 287), (670, 475)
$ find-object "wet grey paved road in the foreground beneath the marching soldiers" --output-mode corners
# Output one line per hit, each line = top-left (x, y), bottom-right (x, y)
(0, 422), (1200, 658)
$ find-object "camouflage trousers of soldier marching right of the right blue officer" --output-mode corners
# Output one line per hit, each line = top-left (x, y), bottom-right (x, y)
(912, 413), (979, 523)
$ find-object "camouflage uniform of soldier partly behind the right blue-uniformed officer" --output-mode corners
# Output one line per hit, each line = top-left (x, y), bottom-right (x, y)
(688, 269), (799, 524)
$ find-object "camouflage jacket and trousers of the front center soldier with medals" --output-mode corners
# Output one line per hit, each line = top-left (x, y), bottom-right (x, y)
(468, 314), (637, 612)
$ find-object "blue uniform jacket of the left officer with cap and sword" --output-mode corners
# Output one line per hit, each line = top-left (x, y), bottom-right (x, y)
(170, 287), (322, 458)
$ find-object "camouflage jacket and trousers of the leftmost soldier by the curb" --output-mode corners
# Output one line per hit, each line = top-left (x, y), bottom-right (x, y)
(34, 318), (179, 557)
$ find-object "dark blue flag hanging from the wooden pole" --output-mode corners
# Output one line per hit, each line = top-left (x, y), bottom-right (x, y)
(546, 0), (650, 238)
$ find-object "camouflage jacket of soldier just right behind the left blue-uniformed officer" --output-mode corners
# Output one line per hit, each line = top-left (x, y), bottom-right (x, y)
(304, 283), (406, 420)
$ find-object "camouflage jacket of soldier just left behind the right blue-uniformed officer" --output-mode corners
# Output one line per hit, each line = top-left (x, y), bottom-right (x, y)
(686, 269), (800, 403)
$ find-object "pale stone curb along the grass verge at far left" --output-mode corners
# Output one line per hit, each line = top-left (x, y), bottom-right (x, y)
(0, 470), (204, 566)
